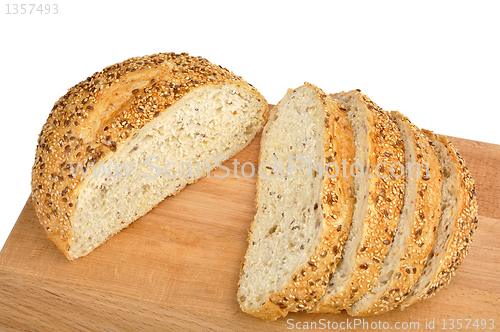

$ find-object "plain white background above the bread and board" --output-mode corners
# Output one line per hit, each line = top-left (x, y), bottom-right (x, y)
(0, 0), (500, 246)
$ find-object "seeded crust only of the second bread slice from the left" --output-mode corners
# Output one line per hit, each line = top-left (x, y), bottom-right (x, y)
(310, 91), (404, 313)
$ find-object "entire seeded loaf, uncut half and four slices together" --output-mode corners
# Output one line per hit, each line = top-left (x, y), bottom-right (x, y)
(31, 53), (478, 320)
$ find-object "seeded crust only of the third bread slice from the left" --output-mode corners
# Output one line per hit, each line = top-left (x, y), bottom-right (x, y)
(347, 112), (443, 316)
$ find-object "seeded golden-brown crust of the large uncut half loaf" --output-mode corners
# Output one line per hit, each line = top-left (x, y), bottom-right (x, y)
(31, 53), (267, 259)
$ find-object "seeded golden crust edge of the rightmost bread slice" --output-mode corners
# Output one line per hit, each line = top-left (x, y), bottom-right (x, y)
(400, 129), (478, 310)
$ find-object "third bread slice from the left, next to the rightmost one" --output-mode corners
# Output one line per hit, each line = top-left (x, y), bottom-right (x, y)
(347, 112), (442, 316)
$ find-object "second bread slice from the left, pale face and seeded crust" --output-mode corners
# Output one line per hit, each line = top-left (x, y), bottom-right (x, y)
(311, 90), (404, 313)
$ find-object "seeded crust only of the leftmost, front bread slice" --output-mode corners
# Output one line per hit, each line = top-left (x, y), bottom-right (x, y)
(238, 83), (354, 321)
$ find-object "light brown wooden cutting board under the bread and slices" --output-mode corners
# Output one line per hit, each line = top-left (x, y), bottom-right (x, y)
(0, 131), (500, 331)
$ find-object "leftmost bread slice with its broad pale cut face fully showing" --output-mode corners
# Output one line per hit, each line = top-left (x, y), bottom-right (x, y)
(237, 83), (354, 320)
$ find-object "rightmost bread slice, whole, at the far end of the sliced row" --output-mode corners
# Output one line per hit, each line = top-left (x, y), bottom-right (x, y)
(401, 130), (478, 309)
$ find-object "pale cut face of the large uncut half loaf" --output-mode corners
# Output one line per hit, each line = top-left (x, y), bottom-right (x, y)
(68, 84), (263, 257)
